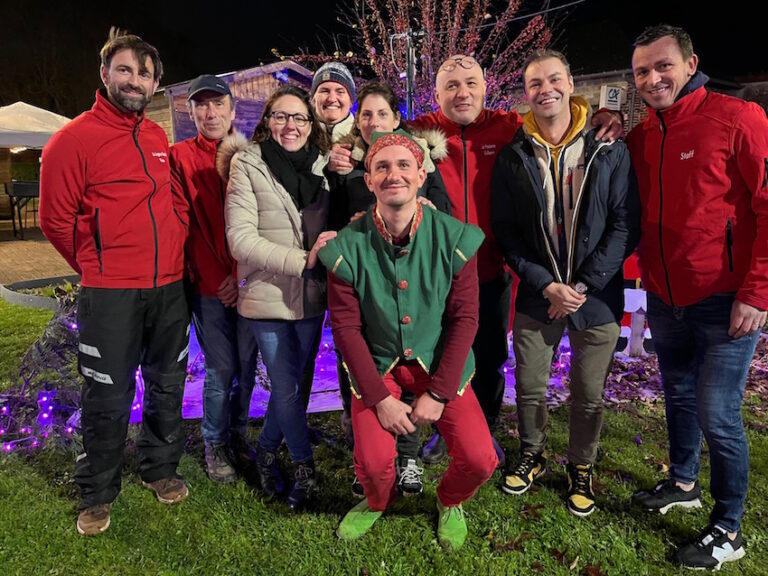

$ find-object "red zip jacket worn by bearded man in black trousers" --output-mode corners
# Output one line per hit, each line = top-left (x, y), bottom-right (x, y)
(40, 89), (186, 288)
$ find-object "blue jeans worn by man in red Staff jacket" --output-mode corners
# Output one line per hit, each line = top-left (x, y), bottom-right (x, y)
(648, 293), (760, 532)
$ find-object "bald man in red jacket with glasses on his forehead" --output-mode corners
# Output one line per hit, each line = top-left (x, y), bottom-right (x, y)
(404, 54), (621, 464)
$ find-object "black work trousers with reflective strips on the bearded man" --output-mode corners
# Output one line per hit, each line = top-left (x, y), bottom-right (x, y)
(75, 281), (189, 509)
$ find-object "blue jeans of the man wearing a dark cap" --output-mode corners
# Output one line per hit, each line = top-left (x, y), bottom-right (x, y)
(192, 296), (257, 445)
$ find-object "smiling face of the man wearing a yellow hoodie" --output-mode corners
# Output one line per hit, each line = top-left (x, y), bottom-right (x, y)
(523, 58), (573, 120)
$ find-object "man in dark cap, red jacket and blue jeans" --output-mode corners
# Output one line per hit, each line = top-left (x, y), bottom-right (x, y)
(171, 74), (257, 483)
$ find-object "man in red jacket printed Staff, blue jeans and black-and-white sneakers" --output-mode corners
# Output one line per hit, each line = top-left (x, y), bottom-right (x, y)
(628, 25), (768, 568)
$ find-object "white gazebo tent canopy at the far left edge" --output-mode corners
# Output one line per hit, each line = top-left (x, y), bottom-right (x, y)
(0, 102), (69, 148)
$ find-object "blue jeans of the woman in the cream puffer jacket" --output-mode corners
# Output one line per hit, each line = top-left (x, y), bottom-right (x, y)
(248, 315), (324, 462)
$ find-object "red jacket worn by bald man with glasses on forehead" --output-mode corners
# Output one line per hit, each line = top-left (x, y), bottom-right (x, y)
(413, 109), (523, 283)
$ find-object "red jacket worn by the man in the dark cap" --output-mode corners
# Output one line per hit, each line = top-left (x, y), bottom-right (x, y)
(171, 134), (237, 296)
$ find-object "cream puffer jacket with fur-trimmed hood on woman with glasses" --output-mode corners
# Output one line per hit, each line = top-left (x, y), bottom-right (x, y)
(216, 134), (329, 320)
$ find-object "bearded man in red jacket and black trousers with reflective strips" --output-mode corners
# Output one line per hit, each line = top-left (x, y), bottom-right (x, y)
(40, 29), (189, 535)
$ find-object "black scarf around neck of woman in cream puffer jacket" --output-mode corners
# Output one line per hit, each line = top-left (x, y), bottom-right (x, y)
(261, 137), (323, 210)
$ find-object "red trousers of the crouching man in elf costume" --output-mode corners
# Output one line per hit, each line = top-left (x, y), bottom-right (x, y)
(352, 361), (498, 510)
